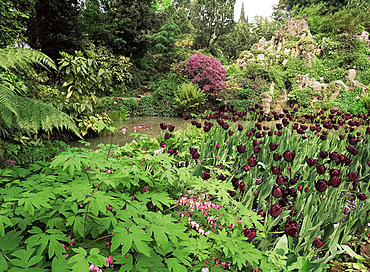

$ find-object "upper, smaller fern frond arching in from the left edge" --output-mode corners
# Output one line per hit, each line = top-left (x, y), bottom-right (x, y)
(0, 47), (57, 70)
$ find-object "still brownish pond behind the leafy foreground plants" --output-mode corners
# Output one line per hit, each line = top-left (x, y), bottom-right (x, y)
(70, 116), (191, 149)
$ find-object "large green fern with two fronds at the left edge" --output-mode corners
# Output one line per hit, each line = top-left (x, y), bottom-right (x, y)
(0, 48), (80, 135)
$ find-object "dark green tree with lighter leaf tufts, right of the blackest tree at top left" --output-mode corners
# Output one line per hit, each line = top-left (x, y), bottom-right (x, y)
(108, 0), (155, 58)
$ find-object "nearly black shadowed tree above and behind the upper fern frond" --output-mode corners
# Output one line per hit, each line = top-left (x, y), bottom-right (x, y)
(27, 0), (83, 60)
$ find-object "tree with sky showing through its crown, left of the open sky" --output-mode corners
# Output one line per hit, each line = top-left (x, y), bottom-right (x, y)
(190, 0), (235, 48)
